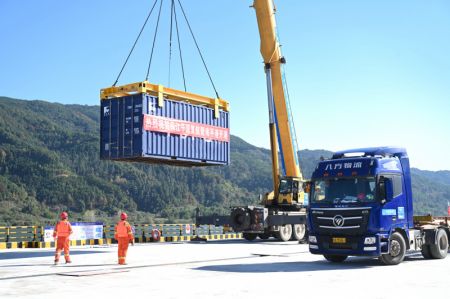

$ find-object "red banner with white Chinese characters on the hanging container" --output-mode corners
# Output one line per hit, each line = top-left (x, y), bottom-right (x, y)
(143, 114), (230, 142)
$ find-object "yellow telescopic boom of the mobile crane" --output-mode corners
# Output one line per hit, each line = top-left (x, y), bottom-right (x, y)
(253, 0), (303, 182)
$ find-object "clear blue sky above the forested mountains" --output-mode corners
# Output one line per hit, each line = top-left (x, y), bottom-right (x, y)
(0, 0), (450, 170)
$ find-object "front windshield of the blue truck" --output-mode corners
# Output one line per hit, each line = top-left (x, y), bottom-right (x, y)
(311, 177), (376, 204)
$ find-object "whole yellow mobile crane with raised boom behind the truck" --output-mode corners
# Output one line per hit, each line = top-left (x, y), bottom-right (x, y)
(231, 0), (306, 241)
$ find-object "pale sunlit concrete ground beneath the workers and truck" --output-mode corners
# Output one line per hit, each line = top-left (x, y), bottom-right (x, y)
(0, 240), (450, 299)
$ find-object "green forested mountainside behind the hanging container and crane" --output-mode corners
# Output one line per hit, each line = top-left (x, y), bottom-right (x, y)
(0, 97), (450, 225)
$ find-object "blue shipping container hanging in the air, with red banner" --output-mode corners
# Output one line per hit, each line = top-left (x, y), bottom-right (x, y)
(100, 94), (230, 166)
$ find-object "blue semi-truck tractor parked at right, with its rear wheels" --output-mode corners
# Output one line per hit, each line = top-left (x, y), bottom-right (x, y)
(307, 147), (449, 265)
